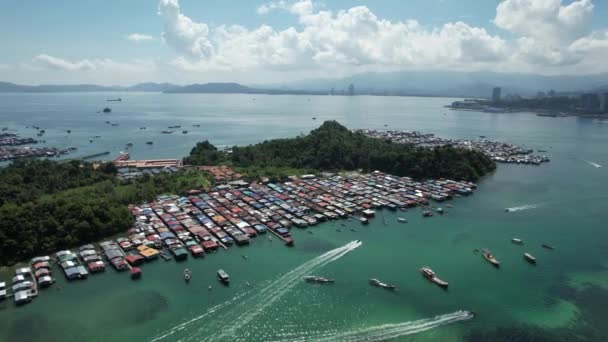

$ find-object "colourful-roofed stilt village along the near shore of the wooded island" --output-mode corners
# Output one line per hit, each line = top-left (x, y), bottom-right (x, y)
(0, 167), (477, 305)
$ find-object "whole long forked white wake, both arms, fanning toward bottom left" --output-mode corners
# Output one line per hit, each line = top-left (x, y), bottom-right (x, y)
(150, 241), (361, 342)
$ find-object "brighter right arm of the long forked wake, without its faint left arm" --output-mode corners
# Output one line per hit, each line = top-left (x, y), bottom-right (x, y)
(204, 241), (361, 341)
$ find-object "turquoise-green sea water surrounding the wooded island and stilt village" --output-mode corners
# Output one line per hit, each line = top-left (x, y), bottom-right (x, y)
(0, 94), (608, 341)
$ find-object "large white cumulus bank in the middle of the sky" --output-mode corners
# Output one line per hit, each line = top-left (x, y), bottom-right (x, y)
(159, 0), (507, 70)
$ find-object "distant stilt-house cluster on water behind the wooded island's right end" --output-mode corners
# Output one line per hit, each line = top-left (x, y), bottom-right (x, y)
(359, 129), (549, 165)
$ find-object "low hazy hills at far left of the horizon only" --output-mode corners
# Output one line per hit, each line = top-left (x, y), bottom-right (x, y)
(0, 82), (179, 93)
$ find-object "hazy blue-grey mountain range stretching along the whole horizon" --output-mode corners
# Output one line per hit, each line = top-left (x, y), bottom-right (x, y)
(0, 71), (608, 97)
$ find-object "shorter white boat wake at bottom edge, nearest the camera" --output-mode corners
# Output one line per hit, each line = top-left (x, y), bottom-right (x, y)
(270, 310), (474, 342)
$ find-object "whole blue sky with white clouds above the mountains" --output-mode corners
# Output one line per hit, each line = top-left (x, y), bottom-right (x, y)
(0, 0), (608, 85)
